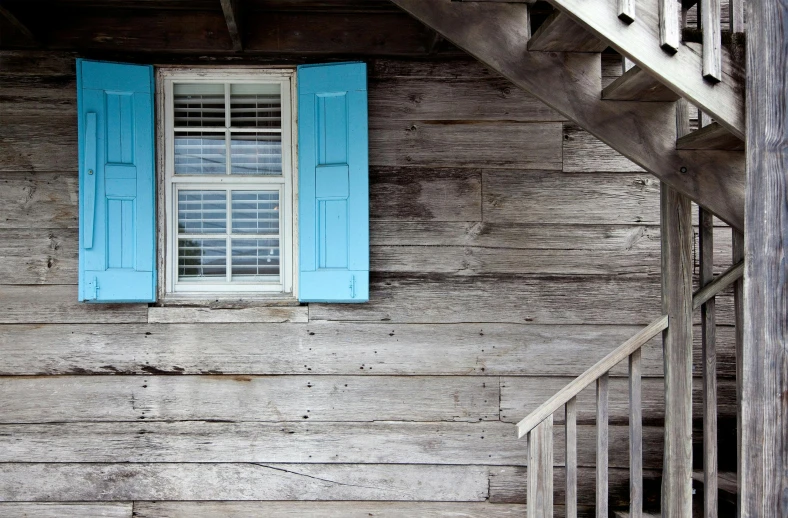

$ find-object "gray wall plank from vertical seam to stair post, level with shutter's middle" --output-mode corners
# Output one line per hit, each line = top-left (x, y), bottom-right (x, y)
(483, 170), (659, 224)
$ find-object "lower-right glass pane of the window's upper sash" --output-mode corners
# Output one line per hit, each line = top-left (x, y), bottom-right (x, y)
(230, 133), (282, 175)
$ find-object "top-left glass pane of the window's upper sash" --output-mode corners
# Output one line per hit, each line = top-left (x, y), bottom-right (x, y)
(173, 83), (225, 128)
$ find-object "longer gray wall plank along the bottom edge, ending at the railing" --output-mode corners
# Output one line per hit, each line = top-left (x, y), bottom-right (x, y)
(134, 502), (526, 518)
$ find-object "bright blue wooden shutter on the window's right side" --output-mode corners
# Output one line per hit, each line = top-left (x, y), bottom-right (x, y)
(298, 63), (369, 302)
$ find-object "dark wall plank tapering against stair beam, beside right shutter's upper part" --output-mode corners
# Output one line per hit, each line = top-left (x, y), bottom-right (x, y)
(369, 77), (565, 122)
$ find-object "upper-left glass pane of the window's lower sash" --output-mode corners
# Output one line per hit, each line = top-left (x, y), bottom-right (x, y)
(178, 191), (227, 234)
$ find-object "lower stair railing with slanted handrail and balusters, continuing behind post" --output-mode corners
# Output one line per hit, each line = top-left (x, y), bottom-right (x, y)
(517, 260), (744, 518)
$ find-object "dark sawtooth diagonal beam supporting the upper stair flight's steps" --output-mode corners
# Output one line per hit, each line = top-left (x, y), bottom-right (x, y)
(392, 0), (744, 229)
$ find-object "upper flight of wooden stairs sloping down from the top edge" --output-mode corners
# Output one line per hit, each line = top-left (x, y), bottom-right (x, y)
(392, 0), (745, 230)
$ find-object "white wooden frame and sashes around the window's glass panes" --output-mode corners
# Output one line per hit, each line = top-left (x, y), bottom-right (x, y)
(157, 68), (298, 300)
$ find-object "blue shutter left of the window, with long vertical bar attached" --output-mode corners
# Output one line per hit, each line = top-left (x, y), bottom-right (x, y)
(77, 59), (156, 302)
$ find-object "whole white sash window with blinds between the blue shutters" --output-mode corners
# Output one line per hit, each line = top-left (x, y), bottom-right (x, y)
(160, 69), (295, 296)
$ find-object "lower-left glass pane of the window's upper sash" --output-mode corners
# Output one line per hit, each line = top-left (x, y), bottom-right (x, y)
(175, 131), (227, 174)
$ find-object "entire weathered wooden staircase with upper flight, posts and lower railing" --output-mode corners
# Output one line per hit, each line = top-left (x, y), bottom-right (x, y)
(392, 0), (746, 518)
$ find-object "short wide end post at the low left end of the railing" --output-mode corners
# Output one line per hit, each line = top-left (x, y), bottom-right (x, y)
(528, 415), (553, 518)
